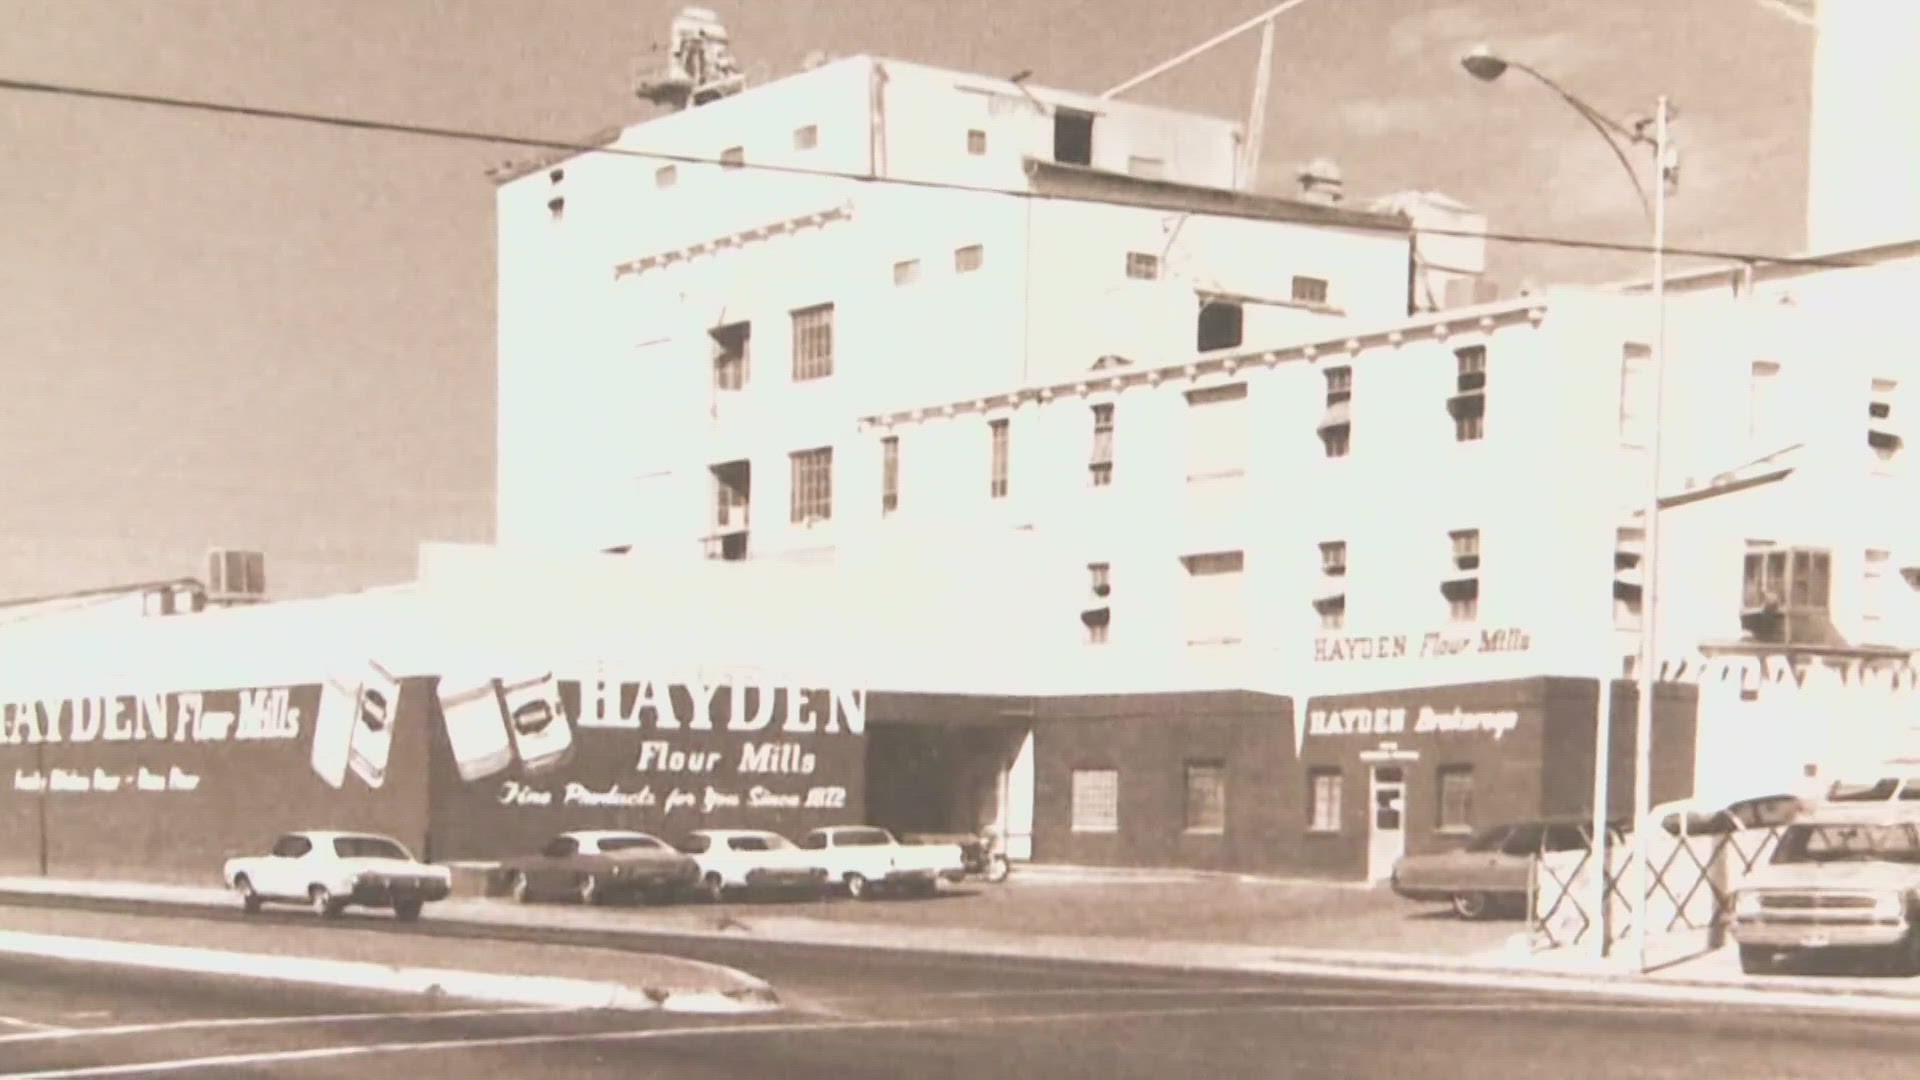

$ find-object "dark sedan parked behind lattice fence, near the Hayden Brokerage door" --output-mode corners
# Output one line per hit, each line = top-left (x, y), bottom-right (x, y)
(1392, 819), (1624, 919)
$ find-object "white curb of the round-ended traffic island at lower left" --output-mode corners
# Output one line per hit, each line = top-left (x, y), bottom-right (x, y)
(0, 930), (781, 1013)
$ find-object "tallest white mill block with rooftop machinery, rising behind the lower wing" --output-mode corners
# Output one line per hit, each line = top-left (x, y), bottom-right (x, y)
(487, 58), (1480, 557)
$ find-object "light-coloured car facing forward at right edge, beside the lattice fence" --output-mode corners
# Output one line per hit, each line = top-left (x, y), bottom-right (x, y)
(1730, 803), (1920, 974)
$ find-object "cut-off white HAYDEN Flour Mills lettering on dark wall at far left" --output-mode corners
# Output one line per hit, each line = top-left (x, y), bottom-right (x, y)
(0, 686), (319, 794)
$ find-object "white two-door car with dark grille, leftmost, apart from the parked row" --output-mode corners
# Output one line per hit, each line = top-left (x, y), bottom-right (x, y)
(221, 832), (453, 922)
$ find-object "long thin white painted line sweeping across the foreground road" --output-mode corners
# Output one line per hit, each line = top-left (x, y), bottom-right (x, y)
(8, 1003), (1728, 1080)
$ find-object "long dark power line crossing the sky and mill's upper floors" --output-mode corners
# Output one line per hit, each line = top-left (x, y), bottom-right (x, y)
(0, 79), (1872, 269)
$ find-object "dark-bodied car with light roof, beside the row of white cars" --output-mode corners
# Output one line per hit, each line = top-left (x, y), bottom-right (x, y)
(501, 828), (701, 903)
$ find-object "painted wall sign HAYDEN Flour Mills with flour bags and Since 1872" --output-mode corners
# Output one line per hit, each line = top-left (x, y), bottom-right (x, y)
(440, 675), (866, 815)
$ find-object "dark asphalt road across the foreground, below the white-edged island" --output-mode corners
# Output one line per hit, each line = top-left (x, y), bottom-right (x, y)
(0, 930), (1920, 1080)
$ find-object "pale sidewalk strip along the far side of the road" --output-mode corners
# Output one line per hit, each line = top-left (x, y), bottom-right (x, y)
(11, 869), (1920, 1015)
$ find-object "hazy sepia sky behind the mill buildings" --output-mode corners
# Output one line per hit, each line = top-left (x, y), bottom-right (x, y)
(0, 0), (1814, 598)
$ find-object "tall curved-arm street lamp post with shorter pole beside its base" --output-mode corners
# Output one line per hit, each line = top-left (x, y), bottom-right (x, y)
(1459, 46), (1674, 970)
